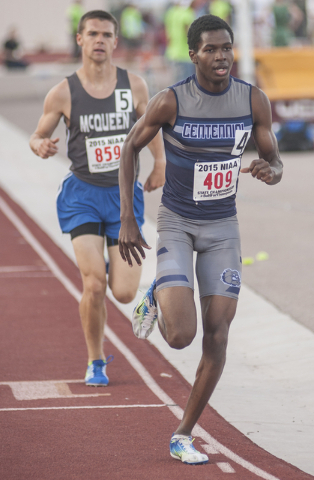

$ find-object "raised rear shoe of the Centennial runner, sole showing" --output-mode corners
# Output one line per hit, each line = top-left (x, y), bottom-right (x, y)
(132, 279), (158, 339)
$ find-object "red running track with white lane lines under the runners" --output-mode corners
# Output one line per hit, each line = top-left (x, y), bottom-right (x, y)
(0, 190), (313, 480)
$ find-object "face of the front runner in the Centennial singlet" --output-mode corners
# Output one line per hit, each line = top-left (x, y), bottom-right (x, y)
(190, 30), (234, 91)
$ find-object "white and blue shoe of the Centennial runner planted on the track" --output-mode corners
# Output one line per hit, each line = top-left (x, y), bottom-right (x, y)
(170, 434), (208, 465)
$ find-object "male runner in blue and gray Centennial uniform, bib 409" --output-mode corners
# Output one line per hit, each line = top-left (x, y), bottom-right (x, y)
(119, 15), (282, 464)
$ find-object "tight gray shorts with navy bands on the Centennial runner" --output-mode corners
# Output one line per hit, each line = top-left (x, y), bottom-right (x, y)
(156, 204), (242, 299)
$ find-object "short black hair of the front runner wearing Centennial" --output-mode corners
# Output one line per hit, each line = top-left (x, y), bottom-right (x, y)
(188, 15), (234, 52)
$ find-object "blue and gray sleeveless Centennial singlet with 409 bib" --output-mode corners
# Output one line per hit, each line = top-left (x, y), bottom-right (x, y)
(162, 75), (253, 220)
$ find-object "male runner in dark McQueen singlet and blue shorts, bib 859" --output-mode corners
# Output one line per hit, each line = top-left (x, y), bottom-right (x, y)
(30, 10), (165, 386)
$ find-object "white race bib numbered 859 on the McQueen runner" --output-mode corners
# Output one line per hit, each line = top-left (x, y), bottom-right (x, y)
(85, 134), (126, 173)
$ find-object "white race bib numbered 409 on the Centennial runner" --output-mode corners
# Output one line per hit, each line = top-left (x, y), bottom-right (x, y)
(193, 158), (241, 201)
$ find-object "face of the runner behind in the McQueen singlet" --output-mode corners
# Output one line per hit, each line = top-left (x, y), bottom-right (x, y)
(77, 18), (118, 63)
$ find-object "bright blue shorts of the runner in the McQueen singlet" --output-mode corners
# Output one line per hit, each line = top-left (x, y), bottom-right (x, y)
(57, 173), (144, 240)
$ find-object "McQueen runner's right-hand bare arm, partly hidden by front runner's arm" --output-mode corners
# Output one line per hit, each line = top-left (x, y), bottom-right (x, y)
(129, 74), (166, 192)
